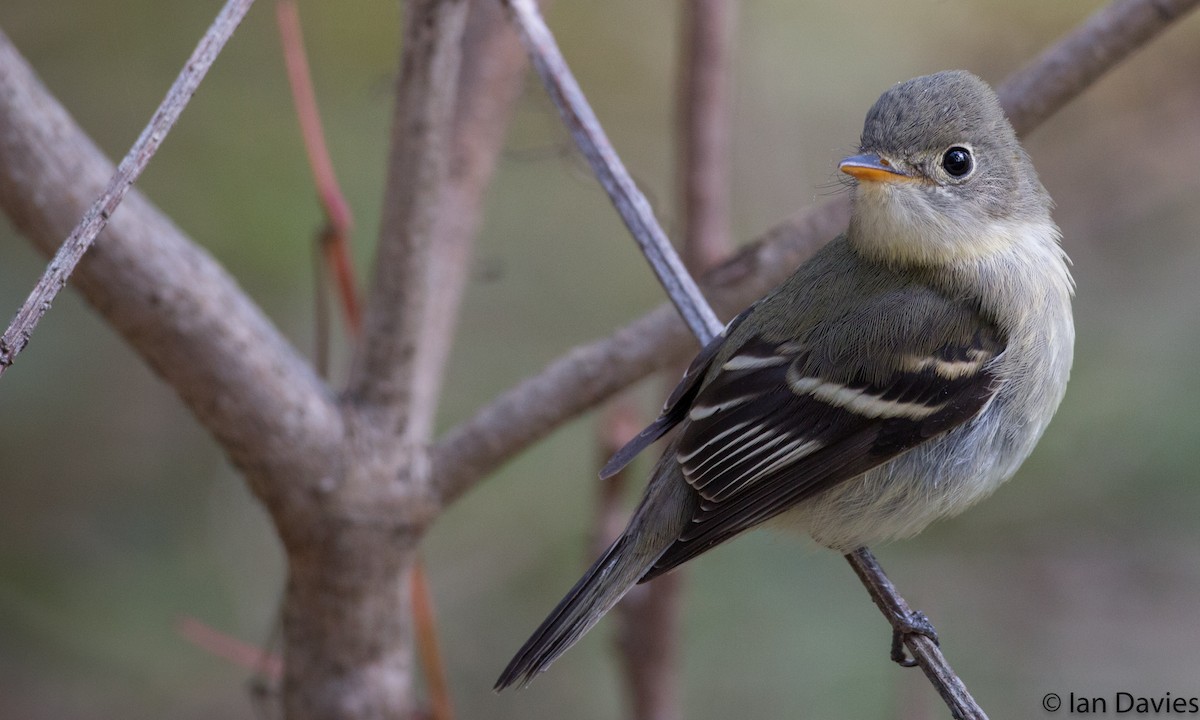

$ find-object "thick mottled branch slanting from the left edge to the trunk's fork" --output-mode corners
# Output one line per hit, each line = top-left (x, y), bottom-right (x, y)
(0, 26), (342, 518)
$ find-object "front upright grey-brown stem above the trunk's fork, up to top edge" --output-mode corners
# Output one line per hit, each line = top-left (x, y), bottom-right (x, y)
(348, 0), (468, 446)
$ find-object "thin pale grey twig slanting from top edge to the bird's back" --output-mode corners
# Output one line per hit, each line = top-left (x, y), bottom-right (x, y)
(504, 0), (721, 342)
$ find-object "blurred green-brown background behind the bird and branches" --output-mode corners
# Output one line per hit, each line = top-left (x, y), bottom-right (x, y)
(0, 0), (1200, 719)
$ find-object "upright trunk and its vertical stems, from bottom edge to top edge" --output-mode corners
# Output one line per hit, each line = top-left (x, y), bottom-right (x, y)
(284, 0), (522, 718)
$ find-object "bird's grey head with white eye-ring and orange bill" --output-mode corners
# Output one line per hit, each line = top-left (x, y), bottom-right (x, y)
(839, 71), (1054, 264)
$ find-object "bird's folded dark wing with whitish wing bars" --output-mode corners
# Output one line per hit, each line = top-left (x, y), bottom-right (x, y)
(642, 313), (1004, 581)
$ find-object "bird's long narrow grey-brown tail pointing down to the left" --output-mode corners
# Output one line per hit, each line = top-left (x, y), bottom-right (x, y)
(496, 448), (694, 691)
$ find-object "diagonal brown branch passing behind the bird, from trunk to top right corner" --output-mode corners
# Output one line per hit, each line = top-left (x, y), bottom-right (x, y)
(433, 0), (1200, 503)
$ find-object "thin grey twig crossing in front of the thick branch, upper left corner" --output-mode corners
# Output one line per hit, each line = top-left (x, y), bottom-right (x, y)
(0, 0), (254, 376)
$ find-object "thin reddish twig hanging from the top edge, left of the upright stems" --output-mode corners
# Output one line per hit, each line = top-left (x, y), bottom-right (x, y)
(275, 0), (362, 338)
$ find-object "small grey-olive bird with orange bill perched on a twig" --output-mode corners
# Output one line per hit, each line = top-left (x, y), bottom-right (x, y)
(496, 71), (1075, 691)
